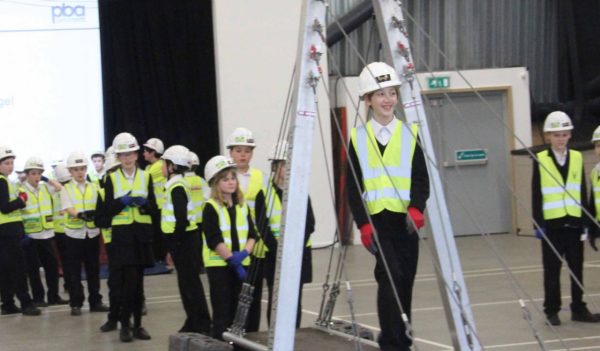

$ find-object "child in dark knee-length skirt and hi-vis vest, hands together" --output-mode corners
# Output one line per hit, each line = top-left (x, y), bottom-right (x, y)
(104, 133), (158, 342)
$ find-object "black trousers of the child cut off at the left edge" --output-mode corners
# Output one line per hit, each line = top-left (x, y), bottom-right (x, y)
(0, 235), (32, 308)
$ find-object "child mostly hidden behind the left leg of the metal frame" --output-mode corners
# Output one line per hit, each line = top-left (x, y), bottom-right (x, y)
(265, 141), (315, 328)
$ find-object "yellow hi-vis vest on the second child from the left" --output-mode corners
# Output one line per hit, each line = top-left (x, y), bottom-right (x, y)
(21, 182), (54, 234)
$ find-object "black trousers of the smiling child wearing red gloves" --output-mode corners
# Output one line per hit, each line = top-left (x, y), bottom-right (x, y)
(375, 229), (419, 351)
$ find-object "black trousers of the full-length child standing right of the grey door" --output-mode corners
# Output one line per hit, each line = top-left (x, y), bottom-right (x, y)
(542, 227), (586, 314)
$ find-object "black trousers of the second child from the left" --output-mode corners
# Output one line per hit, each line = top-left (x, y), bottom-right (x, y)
(23, 238), (59, 303)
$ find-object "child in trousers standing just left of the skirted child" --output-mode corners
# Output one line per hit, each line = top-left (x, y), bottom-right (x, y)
(61, 152), (108, 316)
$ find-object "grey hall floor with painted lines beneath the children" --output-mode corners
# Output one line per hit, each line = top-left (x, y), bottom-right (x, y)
(0, 235), (600, 351)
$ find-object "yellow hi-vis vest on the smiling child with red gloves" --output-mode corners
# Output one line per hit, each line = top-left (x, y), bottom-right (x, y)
(351, 121), (419, 215)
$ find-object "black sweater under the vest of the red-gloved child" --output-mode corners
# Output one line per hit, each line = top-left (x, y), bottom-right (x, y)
(346, 135), (429, 230)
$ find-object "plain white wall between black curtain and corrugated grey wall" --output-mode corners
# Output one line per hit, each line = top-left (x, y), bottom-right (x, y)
(213, 0), (335, 246)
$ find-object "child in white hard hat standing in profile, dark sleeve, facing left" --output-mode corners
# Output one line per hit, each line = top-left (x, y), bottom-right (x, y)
(160, 145), (211, 335)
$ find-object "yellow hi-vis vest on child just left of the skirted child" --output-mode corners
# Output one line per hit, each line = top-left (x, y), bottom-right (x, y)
(65, 180), (99, 229)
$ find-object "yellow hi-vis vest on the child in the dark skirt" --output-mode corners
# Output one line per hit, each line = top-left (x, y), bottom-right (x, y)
(110, 168), (152, 227)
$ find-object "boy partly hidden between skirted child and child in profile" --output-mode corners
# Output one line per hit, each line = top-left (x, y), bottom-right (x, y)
(143, 138), (167, 263)
